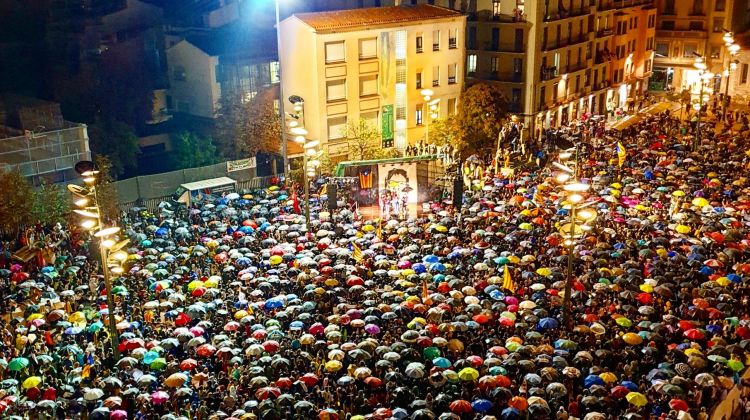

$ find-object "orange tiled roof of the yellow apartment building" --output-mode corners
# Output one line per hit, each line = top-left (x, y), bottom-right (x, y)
(294, 4), (462, 31)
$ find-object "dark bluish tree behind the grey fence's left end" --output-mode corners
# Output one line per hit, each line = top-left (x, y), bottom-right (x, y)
(88, 118), (140, 178)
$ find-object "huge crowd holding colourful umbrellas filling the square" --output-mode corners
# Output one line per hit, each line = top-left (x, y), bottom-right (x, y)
(0, 102), (750, 420)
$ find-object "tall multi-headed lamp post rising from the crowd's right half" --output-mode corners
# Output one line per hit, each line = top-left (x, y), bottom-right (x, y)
(553, 146), (596, 328)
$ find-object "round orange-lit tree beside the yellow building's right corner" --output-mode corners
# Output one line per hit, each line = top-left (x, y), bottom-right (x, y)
(457, 83), (506, 151)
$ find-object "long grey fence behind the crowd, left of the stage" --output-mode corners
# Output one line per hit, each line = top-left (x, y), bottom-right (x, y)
(113, 162), (280, 210)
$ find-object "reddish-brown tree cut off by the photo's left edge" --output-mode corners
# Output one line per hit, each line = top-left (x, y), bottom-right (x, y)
(0, 171), (34, 234)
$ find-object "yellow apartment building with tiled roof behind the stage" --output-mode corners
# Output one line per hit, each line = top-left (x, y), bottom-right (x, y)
(279, 4), (466, 161)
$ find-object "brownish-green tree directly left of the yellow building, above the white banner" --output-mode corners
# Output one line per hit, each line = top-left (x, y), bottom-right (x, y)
(215, 87), (281, 159)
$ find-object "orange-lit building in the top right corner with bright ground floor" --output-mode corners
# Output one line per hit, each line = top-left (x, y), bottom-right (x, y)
(650, 0), (750, 93)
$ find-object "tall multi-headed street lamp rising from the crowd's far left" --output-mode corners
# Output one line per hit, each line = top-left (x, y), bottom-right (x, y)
(68, 161), (129, 361)
